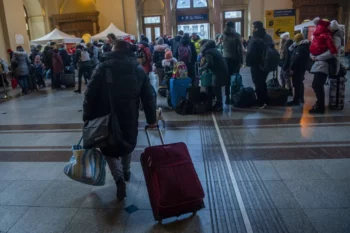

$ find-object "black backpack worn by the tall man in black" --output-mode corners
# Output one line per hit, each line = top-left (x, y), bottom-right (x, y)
(260, 40), (280, 72)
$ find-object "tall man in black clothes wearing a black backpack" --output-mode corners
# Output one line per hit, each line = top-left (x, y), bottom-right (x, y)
(246, 21), (275, 108)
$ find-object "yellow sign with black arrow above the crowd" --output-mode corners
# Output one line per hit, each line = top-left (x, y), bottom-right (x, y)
(265, 9), (295, 40)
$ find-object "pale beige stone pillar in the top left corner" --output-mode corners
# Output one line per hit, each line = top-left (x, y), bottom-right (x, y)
(0, 0), (30, 51)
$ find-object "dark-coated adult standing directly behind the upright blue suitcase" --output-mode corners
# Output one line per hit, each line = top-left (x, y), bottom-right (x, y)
(174, 33), (197, 84)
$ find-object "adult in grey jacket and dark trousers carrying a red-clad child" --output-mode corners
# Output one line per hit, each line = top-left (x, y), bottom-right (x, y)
(309, 20), (344, 114)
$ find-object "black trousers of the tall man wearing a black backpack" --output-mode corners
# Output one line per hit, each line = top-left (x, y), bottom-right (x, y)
(250, 67), (269, 104)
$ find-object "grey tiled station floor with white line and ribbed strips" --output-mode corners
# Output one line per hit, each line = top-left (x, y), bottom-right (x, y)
(0, 69), (350, 233)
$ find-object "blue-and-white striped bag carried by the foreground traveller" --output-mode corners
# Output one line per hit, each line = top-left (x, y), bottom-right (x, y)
(63, 139), (106, 186)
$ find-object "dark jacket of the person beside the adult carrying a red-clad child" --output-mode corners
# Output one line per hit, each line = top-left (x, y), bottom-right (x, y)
(289, 40), (310, 76)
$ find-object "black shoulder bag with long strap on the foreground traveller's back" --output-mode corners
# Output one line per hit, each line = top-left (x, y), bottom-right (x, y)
(83, 69), (123, 148)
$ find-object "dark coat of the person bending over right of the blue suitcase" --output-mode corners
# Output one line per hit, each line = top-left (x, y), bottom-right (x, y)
(201, 40), (229, 87)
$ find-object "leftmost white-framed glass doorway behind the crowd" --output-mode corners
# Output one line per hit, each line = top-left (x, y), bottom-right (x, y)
(143, 16), (163, 42)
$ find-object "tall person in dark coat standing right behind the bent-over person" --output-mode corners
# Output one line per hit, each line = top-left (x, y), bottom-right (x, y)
(222, 21), (243, 104)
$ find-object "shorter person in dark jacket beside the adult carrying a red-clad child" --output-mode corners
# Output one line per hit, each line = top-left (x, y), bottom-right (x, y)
(287, 33), (310, 106)
